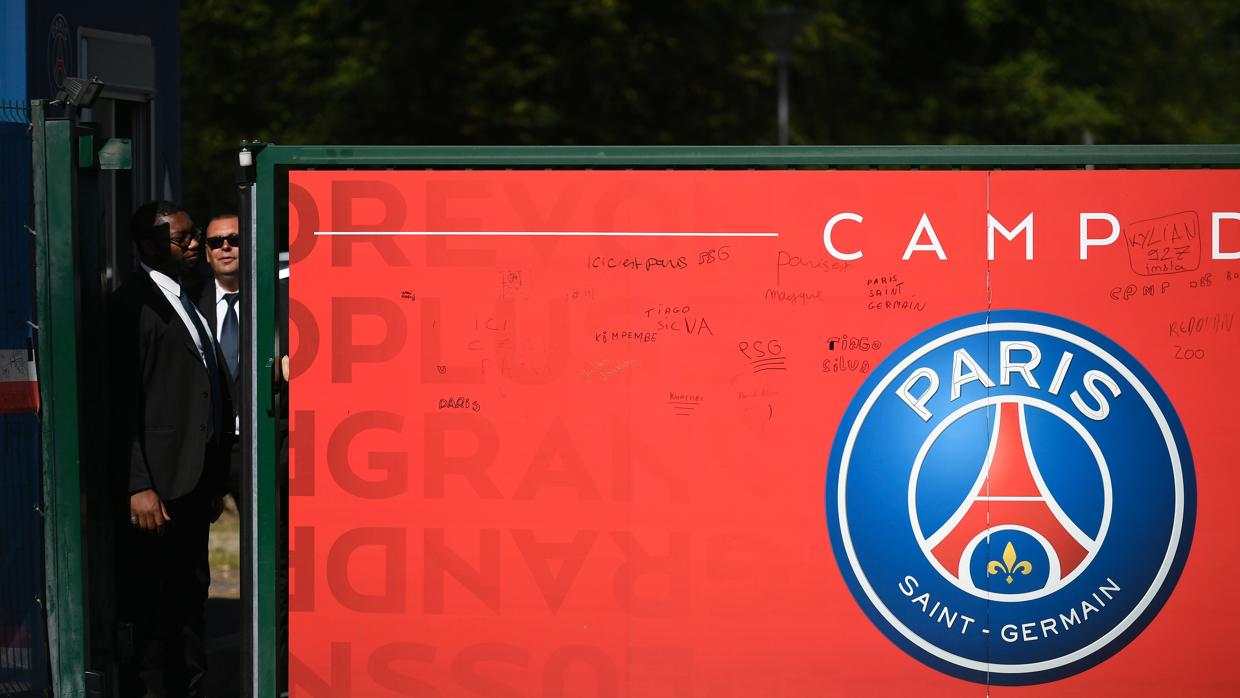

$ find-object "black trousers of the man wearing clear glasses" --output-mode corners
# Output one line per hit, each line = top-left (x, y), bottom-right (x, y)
(117, 484), (212, 698)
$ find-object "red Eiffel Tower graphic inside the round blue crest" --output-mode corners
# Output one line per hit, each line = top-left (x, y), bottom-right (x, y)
(925, 402), (1099, 593)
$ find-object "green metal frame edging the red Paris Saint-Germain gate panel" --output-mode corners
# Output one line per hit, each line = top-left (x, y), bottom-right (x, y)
(239, 141), (1240, 698)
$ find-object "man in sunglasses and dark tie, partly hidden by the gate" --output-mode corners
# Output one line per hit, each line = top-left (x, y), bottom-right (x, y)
(196, 213), (242, 510)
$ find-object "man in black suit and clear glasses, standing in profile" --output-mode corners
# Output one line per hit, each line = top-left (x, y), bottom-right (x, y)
(109, 201), (233, 697)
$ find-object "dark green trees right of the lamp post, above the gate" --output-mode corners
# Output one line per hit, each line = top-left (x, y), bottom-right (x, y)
(794, 0), (1240, 144)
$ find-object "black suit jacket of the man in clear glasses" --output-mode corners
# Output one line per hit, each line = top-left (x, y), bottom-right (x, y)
(109, 270), (232, 500)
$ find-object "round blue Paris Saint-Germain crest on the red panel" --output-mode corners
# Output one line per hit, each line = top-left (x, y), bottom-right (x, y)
(826, 310), (1197, 686)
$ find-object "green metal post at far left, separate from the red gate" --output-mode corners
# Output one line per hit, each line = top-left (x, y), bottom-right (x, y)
(31, 100), (87, 697)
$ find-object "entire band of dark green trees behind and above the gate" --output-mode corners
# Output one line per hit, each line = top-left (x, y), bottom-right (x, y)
(181, 0), (1240, 212)
